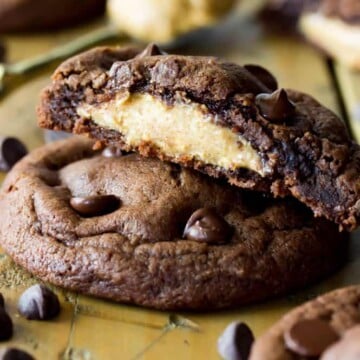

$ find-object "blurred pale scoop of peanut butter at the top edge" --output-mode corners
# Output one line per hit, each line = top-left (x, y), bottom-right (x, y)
(107, 0), (238, 44)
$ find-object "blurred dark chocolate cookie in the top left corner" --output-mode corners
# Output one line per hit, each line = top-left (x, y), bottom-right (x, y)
(0, 0), (106, 32)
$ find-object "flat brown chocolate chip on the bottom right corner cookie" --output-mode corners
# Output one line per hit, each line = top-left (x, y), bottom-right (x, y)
(284, 319), (339, 356)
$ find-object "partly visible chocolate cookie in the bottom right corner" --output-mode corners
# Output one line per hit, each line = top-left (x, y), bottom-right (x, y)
(250, 286), (360, 360)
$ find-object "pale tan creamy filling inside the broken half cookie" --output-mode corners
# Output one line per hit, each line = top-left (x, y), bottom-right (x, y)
(78, 94), (264, 175)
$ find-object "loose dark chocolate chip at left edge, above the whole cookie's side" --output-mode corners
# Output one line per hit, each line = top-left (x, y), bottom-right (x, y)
(0, 136), (28, 171)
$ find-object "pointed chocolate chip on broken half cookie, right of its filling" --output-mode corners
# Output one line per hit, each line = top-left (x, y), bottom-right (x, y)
(255, 89), (295, 122)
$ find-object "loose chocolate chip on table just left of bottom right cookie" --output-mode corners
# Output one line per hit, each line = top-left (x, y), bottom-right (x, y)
(218, 322), (254, 360)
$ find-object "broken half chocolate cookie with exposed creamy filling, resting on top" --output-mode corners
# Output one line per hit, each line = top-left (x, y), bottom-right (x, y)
(38, 45), (360, 230)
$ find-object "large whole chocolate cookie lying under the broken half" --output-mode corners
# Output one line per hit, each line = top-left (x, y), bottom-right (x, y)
(0, 138), (346, 310)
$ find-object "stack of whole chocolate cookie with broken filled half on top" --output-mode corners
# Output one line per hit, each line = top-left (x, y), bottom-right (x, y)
(0, 45), (360, 310)
